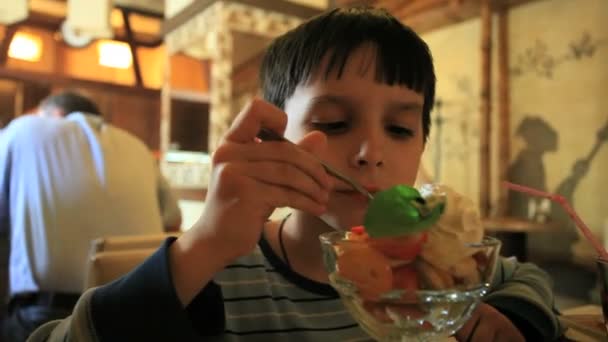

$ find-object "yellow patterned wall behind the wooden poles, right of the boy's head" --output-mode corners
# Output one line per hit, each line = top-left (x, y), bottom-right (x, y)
(424, 0), (608, 262)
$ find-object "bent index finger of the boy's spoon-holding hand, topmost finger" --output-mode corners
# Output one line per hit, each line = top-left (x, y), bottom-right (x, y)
(224, 99), (287, 143)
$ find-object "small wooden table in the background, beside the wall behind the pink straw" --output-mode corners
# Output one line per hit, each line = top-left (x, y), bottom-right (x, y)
(482, 217), (554, 261)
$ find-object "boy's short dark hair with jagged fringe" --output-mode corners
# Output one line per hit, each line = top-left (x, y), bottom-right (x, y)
(260, 7), (436, 140)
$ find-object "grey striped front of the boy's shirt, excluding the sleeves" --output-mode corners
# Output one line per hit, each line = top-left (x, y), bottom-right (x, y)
(210, 239), (372, 342)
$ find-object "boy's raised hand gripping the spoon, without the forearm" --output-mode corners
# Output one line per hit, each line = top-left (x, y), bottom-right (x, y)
(201, 100), (329, 258)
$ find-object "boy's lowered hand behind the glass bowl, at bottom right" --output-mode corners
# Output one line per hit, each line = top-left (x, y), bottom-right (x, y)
(456, 303), (525, 342)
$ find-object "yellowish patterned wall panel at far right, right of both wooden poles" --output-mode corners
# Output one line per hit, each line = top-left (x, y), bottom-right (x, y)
(509, 0), (608, 262)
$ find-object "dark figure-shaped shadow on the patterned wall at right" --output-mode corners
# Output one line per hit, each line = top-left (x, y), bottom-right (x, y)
(508, 116), (608, 261)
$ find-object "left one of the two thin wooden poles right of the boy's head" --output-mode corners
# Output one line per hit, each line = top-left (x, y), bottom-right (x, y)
(479, 0), (492, 217)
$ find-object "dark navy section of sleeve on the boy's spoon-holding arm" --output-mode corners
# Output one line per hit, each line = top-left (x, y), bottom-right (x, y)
(91, 238), (224, 341)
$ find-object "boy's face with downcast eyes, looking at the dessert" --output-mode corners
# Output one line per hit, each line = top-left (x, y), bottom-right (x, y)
(285, 46), (424, 228)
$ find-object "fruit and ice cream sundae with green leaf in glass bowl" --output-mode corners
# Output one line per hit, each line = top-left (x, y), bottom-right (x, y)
(321, 185), (500, 341)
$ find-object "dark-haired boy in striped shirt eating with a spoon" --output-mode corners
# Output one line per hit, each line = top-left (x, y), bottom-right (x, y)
(28, 8), (559, 341)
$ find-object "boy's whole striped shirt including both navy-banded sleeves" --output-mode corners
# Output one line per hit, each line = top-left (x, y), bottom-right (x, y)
(28, 238), (563, 342)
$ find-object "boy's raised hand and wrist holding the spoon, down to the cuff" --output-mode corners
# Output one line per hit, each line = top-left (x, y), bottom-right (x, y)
(171, 100), (331, 305)
